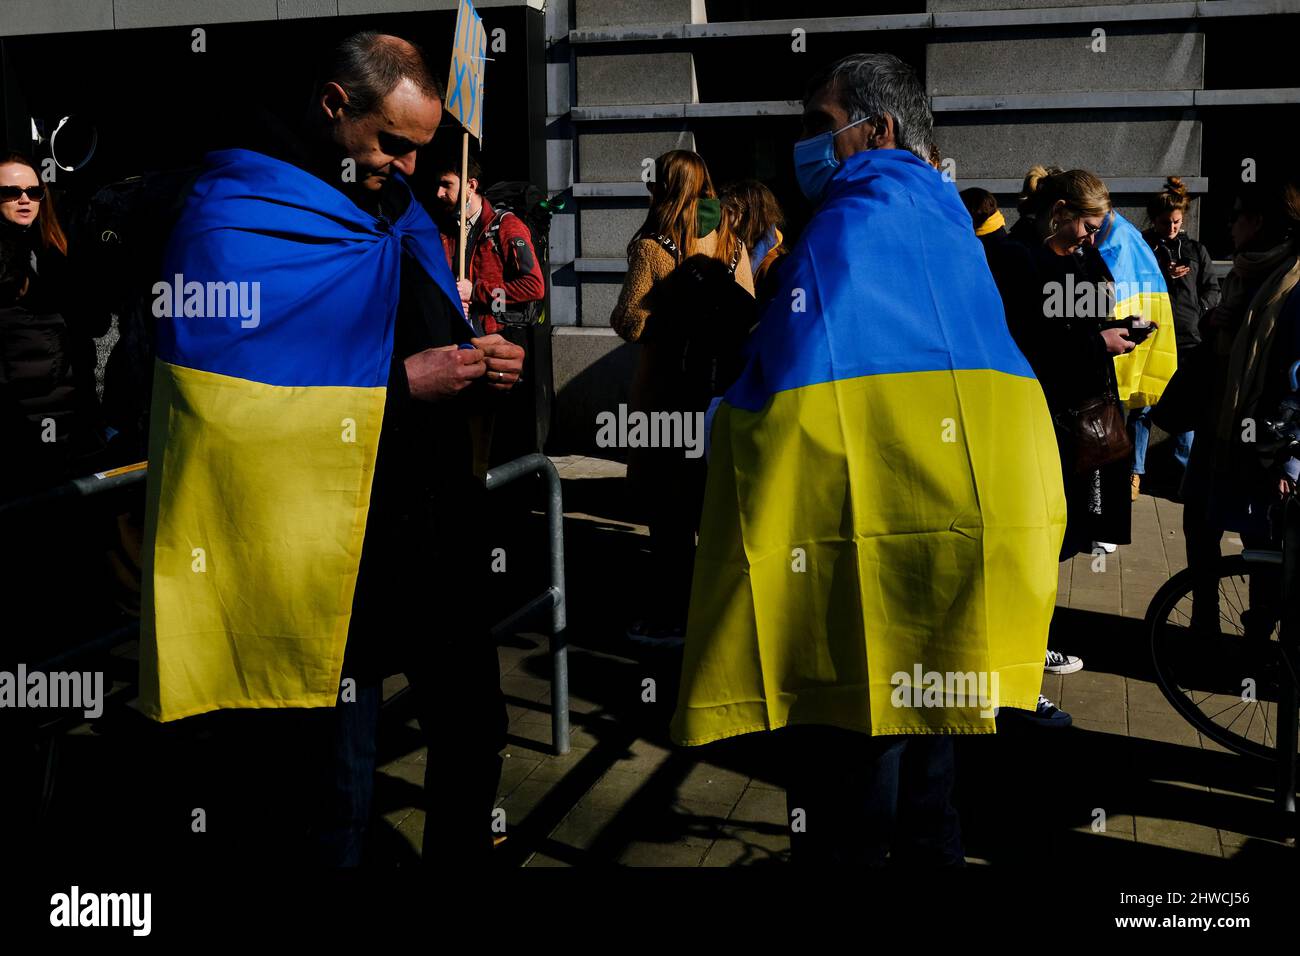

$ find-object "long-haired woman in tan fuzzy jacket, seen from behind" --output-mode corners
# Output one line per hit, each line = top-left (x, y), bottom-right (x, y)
(610, 150), (754, 645)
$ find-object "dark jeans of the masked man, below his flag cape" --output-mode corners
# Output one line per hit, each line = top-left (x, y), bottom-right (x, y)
(777, 727), (966, 866)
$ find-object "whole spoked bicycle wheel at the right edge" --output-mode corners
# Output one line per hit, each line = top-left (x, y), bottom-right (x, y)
(1147, 555), (1288, 761)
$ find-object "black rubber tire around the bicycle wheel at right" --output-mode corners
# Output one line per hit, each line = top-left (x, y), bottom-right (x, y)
(1144, 555), (1278, 762)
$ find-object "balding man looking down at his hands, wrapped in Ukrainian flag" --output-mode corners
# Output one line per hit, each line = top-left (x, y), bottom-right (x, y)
(142, 33), (523, 865)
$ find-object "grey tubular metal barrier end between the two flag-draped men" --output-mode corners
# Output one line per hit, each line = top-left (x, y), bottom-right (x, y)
(485, 454), (569, 753)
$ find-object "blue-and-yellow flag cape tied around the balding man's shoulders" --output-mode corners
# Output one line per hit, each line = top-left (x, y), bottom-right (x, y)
(140, 150), (459, 721)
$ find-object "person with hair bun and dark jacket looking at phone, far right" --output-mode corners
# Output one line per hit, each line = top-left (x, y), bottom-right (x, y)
(1128, 176), (1219, 501)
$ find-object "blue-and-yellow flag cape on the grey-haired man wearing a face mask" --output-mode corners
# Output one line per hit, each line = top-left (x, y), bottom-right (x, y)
(672, 150), (1066, 745)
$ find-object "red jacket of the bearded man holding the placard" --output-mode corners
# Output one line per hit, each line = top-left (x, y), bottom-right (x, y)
(442, 199), (546, 334)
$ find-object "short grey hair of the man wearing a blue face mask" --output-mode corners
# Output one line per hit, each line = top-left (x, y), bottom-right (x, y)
(803, 53), (935, 163)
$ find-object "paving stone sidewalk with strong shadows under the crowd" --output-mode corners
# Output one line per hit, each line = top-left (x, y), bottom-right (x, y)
(373, 457), (1295, 866)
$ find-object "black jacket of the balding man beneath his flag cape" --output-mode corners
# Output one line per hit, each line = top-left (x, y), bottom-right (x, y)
(241, 114), (501, 676)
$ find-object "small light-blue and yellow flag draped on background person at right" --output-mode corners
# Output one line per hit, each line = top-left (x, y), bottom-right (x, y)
(1097, 209), (1178, 408)
